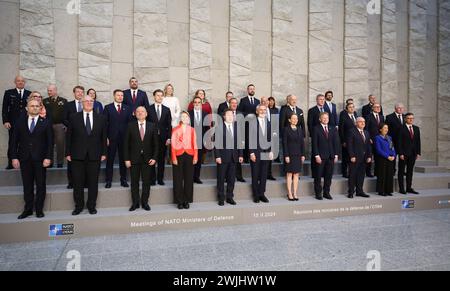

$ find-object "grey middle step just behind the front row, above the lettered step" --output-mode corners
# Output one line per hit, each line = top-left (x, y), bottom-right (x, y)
(0, 173), (450, 214)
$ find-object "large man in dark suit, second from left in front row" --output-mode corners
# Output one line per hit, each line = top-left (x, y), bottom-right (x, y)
(66, 96), (108, 216)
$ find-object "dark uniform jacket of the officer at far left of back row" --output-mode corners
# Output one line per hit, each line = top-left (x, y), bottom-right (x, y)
(2, 89), (31, 124)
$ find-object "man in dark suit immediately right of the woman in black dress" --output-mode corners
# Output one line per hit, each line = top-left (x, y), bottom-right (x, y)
(311, 112), (339, 200)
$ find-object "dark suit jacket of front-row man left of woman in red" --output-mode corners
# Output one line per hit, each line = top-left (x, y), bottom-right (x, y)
(123, 121), (159, 165)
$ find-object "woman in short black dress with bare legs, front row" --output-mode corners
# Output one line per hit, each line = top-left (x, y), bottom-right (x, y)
(283, 114), (305, 201)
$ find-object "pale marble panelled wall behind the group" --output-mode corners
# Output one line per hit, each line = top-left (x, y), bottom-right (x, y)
(0, 0), (450, 165)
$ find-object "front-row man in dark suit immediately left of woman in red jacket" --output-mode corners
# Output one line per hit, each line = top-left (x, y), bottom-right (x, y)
(124, 107), (159, 211)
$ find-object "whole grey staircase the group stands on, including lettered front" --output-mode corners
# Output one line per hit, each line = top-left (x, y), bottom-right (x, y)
(0, 161), (450, 243)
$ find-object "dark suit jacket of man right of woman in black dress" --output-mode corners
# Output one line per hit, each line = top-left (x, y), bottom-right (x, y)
(312, 124), (340, 160)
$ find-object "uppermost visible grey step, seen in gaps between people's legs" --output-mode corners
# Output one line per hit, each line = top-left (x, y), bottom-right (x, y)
(0, 161), (341, 187)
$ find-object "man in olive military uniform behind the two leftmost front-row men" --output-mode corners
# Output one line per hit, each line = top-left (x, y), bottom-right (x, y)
(43, 85), (67, 168)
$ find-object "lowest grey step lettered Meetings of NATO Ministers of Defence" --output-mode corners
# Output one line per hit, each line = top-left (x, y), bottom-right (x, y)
(0, 189), (450, 243)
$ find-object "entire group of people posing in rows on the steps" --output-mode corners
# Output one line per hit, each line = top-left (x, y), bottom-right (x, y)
(2, 76), (421, 219)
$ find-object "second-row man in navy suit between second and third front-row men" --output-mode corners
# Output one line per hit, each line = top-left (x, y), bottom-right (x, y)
(103, 90), (133, 189)
